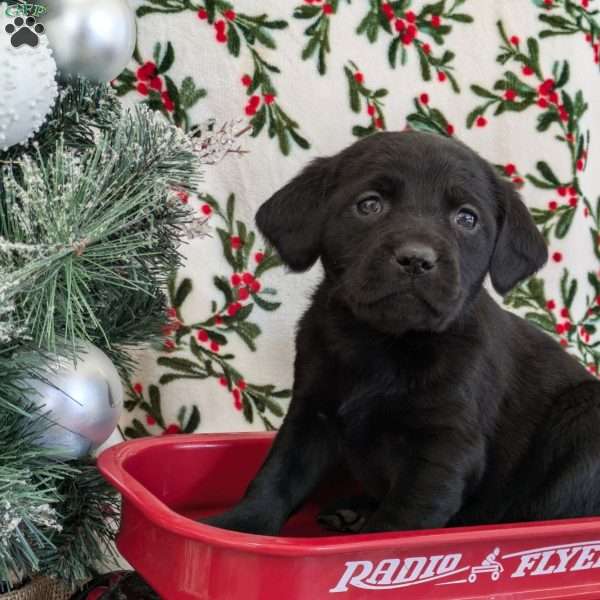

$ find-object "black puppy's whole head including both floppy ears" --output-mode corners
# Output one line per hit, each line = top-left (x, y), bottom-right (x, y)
(256, 131), (547, 334)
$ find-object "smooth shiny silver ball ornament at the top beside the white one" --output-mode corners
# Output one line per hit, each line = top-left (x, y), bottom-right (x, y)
(41, 0), (137, 82)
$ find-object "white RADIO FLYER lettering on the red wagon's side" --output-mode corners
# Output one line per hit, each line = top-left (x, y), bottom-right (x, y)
(329, 540), (600, 593)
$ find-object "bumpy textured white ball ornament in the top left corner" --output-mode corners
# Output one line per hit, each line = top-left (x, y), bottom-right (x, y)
(0, 2), (58, 150)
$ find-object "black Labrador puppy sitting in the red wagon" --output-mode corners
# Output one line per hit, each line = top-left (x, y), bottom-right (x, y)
(207, 132), (600, 535)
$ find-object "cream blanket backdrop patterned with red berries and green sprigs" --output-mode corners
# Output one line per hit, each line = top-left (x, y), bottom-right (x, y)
(106, 0), (600, 437)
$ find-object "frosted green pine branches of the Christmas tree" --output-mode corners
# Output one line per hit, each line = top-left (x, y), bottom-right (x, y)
(0, 80), (199, 583)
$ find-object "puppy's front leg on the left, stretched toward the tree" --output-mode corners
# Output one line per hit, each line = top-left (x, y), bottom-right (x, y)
(204, 397), (336, 535)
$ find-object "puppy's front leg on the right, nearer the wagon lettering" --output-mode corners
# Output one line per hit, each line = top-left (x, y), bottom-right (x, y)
(362, 432), (484, 532)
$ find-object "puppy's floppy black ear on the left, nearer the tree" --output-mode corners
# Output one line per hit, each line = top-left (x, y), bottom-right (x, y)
(256, 158), (334, 271)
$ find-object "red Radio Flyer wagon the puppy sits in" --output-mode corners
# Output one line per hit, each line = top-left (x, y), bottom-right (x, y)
(98, 434), (600, 600)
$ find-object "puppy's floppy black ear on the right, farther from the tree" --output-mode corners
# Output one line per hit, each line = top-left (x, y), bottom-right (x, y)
(490, 175), (548, 296)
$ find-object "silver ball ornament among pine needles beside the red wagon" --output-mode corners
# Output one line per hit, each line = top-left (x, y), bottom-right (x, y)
(27, 342), (123, 458)
